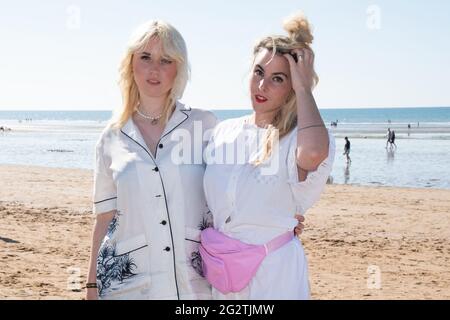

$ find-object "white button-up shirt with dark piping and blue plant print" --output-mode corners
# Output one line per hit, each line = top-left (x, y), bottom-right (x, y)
(94, 103), (216, 299)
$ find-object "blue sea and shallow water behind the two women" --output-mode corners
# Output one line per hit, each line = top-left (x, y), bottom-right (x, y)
(0, 107), (450, 189)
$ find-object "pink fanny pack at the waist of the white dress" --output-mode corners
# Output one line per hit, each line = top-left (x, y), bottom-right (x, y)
(200, 228), (294, 294)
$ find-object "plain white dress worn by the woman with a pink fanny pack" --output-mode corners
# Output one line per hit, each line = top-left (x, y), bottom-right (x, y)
(204, 117), (335, 300)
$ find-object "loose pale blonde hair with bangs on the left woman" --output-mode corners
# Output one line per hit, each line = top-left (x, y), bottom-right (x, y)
(112, 20), (190, 128)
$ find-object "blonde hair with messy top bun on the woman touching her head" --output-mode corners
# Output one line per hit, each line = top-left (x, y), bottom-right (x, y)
(253, 13), (319, 165)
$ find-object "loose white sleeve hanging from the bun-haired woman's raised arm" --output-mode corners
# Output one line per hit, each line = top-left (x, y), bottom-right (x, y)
(287, 130), (336, 214)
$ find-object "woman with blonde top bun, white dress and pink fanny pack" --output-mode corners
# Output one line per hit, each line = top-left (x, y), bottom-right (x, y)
(202, 11), (335, 299)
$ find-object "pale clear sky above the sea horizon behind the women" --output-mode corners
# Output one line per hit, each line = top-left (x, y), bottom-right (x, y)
(0, 0), (450, 110)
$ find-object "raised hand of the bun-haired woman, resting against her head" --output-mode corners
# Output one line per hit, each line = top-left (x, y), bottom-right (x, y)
(284, 49), (315, 93)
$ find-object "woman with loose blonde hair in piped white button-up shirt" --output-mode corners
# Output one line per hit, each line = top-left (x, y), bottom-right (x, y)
(86, 21), (216, 299)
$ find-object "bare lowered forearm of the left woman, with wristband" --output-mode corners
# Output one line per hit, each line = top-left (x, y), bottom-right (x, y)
(86, 210), (116, 300)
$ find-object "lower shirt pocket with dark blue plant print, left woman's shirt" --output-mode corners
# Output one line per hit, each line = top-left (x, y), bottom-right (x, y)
(97, 234), (151, 299)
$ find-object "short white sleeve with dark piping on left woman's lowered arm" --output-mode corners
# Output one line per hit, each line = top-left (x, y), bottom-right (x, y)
(93, 138), (117, 214)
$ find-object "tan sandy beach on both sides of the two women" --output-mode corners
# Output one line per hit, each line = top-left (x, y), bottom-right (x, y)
(0, 165), (450, 299)
